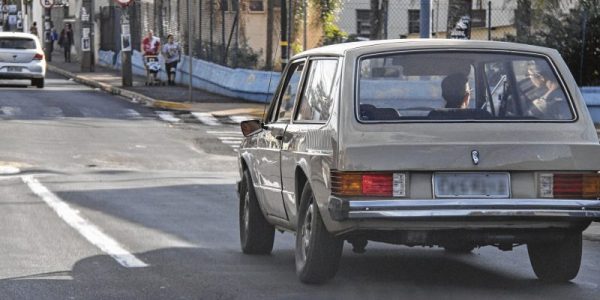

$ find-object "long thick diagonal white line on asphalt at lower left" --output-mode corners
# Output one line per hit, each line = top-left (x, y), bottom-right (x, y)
(21, 175), (148, 268)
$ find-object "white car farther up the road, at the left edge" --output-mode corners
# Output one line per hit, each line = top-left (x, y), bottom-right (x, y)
(0, 32), (46, 88)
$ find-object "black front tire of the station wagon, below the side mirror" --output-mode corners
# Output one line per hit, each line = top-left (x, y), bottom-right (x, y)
(239, 170), (275, 254)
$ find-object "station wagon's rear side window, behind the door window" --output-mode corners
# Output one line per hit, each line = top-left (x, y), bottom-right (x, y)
(295, 59), (338, 122)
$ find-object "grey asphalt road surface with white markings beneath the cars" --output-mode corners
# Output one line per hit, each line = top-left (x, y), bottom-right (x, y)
(0, 76), (600, 299)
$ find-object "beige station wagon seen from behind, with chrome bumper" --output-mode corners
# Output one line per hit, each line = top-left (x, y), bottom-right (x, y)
(238, 40), (600, 283)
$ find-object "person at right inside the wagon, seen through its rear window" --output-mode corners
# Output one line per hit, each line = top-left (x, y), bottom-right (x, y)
(527, 63), (570, 119)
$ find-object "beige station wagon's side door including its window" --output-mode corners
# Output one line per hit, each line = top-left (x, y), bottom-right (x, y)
(256, 60), (305, 220)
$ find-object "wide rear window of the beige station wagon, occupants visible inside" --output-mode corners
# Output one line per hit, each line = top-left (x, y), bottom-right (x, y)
(357, 51), (574, 122)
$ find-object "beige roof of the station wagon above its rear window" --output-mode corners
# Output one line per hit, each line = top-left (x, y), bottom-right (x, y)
(293, 39), (556, 59)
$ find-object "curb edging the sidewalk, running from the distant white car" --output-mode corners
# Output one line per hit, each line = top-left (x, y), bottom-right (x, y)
(47, 64), (191, 111)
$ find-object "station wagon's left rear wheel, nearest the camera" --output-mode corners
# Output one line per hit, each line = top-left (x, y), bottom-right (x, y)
(296, 183), (344, 283)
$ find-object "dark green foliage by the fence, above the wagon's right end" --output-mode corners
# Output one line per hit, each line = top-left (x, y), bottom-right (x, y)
(507, 0), (600, 86)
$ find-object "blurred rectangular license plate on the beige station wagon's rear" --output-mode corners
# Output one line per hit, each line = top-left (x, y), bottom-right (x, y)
(433, 172), (510, 198)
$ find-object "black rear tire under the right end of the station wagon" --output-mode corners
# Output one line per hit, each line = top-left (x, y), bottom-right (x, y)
(527, 232), (582, 282)
